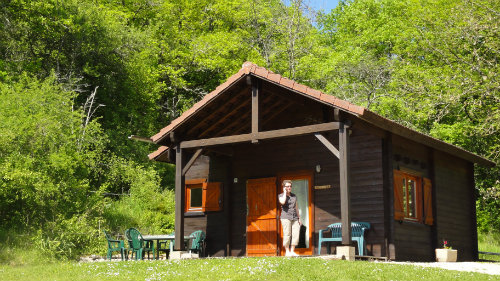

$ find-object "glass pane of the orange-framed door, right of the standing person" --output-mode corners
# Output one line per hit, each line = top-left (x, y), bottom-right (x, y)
(292, 179), (309, 248)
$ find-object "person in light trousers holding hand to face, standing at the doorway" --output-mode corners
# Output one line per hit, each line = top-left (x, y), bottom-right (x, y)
(278, 180), (302, 257)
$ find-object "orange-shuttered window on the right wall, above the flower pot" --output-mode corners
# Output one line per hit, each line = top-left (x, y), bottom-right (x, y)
(394, 170), (433, 225)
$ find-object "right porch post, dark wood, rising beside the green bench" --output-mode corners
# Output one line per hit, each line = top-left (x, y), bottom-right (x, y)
(339, 122), (351, 245)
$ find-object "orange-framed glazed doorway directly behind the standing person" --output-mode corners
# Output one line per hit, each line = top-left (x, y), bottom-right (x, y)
(276, 171), (314, 256)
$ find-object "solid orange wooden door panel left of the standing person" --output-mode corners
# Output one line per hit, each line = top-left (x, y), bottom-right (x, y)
(247, 178), (278, 256)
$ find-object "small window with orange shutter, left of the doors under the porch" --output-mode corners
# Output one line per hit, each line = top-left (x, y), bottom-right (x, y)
(186, 179), (222, 212)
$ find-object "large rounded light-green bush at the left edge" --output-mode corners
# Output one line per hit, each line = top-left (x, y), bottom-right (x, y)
(0, 75), (101, 226)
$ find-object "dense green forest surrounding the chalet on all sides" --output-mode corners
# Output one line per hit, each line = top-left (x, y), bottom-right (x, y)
(0, 0), (500, 262)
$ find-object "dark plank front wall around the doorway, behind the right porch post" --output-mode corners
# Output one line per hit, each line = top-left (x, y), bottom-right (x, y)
(230, 124), (385, 256)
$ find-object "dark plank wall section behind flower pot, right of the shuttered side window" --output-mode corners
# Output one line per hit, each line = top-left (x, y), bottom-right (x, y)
(434, 152), (477, 261)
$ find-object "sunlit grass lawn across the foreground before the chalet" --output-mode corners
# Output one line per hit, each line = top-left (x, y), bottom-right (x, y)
(0, 258), (499, 281)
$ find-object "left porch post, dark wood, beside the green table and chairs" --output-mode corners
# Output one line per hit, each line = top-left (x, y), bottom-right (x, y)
(174, 144), (185, 251)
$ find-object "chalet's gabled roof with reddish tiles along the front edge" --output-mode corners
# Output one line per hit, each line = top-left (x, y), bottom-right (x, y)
(148, 62), (495, 166)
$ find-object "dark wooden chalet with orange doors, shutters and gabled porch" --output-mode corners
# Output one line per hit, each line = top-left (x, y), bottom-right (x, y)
(149, 62), (494, 261)
